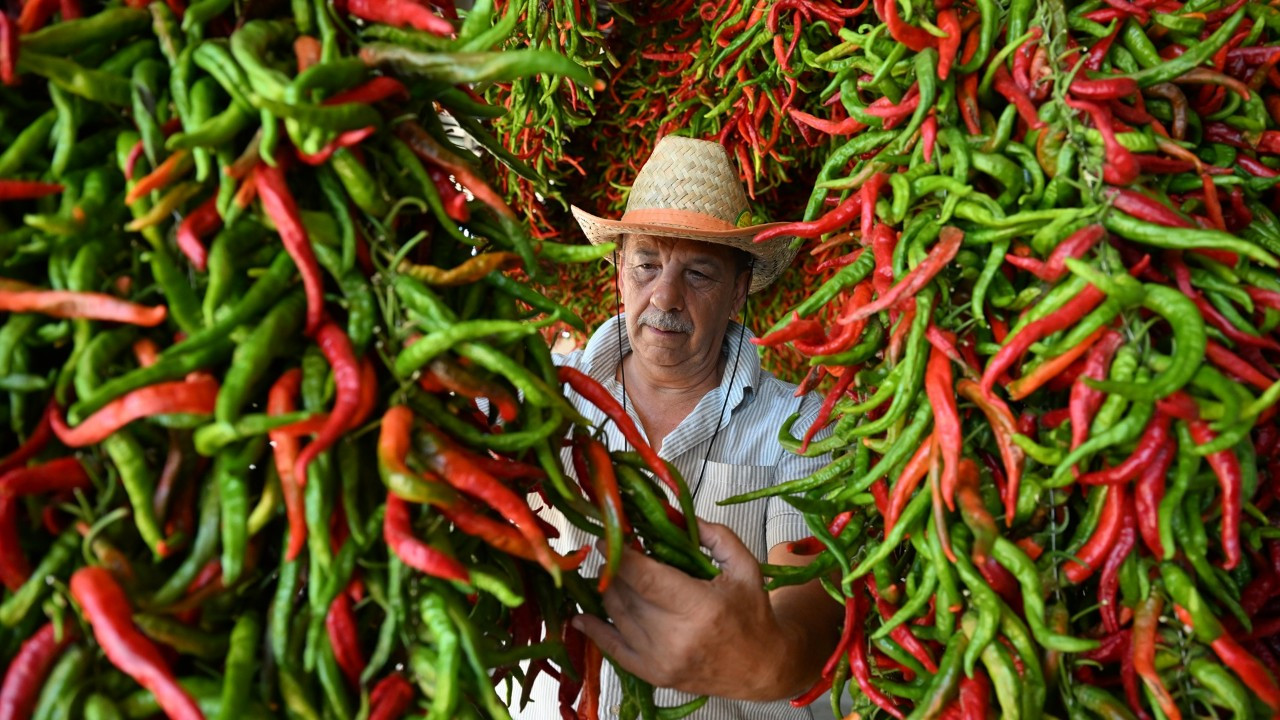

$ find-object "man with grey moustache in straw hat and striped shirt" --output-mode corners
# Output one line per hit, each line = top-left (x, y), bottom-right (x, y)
(522, 136), (841, 720)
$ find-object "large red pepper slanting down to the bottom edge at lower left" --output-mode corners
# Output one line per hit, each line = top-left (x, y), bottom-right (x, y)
(70, 566), (204, 720)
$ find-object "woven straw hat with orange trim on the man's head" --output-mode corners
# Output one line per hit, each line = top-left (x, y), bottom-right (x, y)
(573, 135), (796, 292)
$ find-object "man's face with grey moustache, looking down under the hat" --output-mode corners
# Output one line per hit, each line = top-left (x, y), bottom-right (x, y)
(618, 234), (749, 366)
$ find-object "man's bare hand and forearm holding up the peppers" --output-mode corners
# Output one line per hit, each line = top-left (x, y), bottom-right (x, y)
(573, 521), (838, 701)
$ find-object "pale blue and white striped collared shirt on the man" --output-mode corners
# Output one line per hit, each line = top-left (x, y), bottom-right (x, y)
(512, 315), (827, 720)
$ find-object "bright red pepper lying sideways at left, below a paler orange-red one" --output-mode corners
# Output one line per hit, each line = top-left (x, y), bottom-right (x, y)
(50, 375), (218, 447)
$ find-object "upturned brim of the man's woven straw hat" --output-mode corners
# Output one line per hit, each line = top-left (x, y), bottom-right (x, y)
(570, 205), (796, 293)
